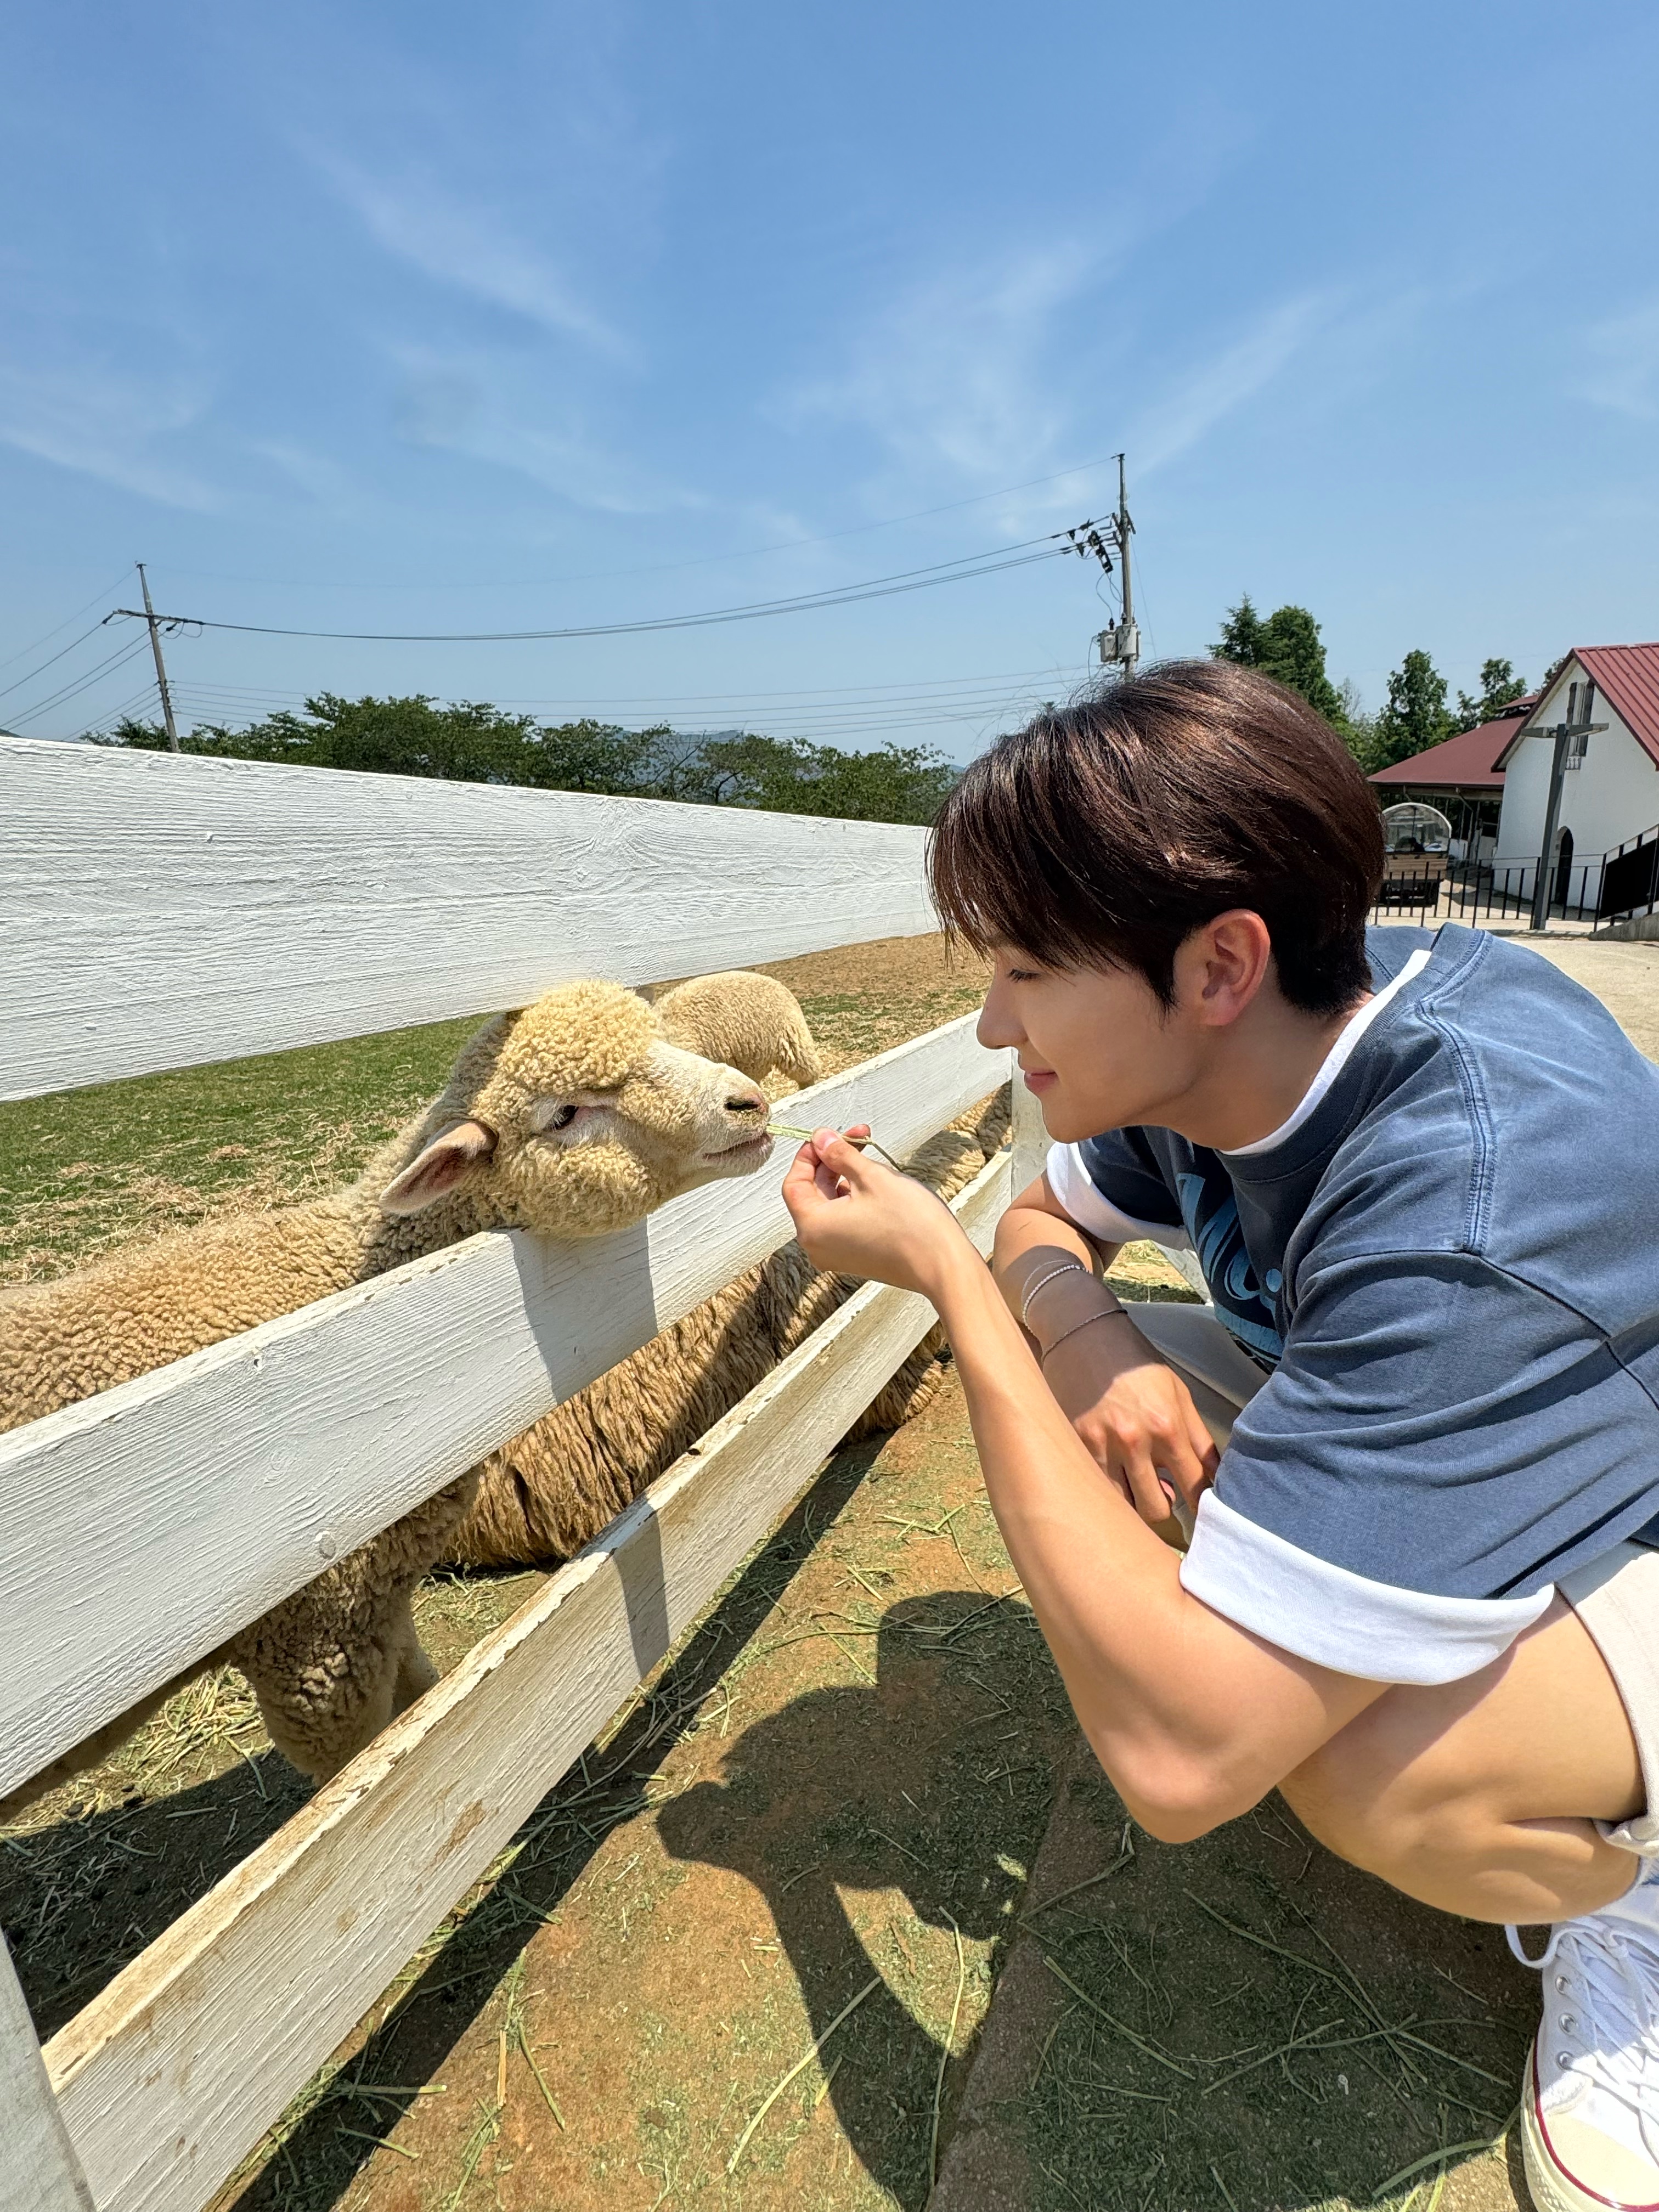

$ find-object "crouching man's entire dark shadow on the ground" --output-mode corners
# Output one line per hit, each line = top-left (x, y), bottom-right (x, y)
(657, 1590), (1537, 2212)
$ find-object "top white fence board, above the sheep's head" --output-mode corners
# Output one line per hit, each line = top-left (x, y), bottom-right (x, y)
(0, 739), (938, 1099)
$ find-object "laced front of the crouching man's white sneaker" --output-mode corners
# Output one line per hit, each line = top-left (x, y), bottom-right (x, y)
(1504, 1914), (1659, 2163)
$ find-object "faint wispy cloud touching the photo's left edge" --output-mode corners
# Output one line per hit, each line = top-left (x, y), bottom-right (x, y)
(0, 358), (219, 511)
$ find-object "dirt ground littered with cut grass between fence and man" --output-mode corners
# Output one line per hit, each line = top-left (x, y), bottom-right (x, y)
(217, 1378), (1537, 2212)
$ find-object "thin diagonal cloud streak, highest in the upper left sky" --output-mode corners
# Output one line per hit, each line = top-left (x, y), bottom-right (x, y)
(305, 144), (630, 360)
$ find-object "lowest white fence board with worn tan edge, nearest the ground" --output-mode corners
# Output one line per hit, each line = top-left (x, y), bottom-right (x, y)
(47, 1153), (1009, 2212)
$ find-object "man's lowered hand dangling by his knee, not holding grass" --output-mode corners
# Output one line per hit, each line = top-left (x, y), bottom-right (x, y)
(1042, 1312), (1219, 1528)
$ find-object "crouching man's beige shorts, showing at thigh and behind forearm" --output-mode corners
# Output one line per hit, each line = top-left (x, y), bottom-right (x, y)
(1128, 1305), (1659, 1858)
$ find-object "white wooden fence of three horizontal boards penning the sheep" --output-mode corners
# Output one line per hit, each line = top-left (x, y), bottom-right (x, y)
(0, 739), (1011, 2212)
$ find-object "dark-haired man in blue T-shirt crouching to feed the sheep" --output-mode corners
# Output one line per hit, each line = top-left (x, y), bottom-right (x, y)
(785, 662), (1659, 2212)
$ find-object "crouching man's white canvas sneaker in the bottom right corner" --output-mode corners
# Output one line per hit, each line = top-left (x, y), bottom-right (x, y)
(1509, 1860), (1659, 2212)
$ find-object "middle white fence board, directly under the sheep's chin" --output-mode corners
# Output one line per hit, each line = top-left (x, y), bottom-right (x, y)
(0, 1015), (1009, 1794)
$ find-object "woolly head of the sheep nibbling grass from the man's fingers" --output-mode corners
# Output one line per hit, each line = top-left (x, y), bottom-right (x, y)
(381, 982), (772, 1237)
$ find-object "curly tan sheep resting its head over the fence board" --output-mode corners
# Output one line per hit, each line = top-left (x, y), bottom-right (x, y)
(0, 978), (805, 1816)
